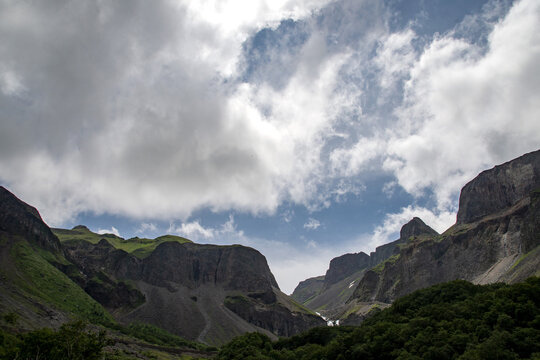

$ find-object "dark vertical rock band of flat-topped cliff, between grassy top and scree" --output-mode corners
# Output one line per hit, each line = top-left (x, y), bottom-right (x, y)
(64, 239), (279, 292)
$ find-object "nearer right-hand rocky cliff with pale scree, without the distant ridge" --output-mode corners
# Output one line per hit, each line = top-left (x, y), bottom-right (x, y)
(352, 151), (540, 302)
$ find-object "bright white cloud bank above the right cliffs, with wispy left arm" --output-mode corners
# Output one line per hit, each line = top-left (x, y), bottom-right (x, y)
(329, 0), (540, 218)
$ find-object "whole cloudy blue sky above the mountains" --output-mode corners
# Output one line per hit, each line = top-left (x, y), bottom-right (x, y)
(0, 0), (540, 293)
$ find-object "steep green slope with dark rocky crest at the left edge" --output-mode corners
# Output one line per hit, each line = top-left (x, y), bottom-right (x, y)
(0, 187), (114, 330)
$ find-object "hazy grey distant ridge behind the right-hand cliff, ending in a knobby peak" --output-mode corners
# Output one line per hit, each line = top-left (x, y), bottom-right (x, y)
(291, 217), (438, 319)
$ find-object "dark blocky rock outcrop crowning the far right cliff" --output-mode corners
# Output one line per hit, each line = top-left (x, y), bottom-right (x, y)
(457, 150), (540, 224)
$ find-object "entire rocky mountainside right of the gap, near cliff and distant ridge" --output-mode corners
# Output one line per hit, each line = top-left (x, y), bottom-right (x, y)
(292, 150), (540, 323)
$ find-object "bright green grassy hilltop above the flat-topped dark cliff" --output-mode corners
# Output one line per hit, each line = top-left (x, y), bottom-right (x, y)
(52, 226), (191, 258)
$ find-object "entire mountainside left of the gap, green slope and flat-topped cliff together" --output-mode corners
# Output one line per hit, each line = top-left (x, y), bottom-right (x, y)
(0, 188), (324, 345)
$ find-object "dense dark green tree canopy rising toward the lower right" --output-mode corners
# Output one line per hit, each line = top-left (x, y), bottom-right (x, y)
(216, 278), (540, 360)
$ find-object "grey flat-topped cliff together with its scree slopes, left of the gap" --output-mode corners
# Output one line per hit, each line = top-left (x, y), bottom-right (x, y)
(63, 230), (324, 344)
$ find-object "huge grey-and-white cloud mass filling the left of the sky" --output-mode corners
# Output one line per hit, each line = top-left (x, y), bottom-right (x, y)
(0, 1), (354, 225)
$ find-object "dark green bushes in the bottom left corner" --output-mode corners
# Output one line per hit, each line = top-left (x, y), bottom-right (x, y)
(0, 321), (107, 360)
